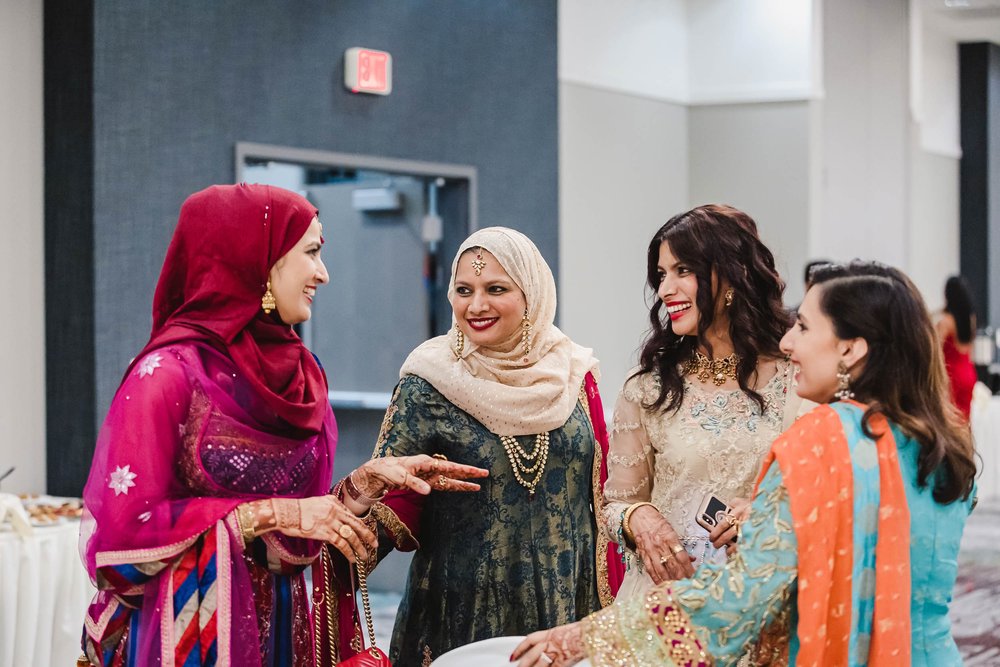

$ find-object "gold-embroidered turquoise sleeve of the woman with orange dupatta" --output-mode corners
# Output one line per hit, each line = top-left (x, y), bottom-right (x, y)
(583, 466), (797, 667)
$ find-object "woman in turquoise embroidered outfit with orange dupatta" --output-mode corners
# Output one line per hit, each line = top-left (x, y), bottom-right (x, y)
(514, 262), (975, 667)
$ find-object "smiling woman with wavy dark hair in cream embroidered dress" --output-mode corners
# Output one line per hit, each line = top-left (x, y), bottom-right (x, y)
(592, 204), (797, 597)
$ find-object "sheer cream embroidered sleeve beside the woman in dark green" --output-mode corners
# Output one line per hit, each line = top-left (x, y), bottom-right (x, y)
(604, 379), (653, 542)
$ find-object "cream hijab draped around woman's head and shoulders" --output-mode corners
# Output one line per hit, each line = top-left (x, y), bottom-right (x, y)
(399, 227), (598, 435)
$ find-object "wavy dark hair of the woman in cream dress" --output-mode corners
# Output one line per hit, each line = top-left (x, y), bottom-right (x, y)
(635, 204), (791, 411)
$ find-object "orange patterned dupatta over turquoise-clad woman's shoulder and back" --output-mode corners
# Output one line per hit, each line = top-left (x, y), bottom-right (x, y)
(757, 401), (911, 667)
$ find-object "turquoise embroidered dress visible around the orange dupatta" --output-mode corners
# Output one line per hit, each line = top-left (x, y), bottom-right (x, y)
(585, 403), (975, 667)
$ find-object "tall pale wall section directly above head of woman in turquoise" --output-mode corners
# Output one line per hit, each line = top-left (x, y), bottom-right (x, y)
(811, 0), (910, 270)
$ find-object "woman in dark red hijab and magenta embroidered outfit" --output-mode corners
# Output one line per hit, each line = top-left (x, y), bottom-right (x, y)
(81, 185), (486, 667)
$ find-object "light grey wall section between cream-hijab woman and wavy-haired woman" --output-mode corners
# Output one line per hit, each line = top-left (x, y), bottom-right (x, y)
(559, 82), (688, 400)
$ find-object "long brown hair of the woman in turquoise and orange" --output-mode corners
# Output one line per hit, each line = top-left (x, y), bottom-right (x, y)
(812, 261), (976, 504)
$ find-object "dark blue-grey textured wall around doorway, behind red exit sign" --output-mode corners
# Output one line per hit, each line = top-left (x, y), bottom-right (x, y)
(47, 0), (558, 493)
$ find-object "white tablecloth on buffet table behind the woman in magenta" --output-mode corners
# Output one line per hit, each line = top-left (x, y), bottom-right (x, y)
(0, 521), (95, 667)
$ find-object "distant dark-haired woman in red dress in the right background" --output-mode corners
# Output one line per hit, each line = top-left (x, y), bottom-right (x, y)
(935, 276), (976, 420)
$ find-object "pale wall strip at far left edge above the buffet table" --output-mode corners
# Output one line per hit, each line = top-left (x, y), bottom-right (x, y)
(0, 0), (45, 492)
